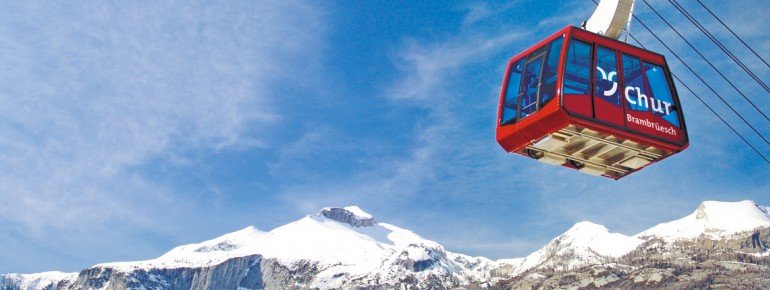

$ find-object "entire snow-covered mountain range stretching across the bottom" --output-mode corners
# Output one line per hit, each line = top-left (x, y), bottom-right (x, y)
(6, 201), (770, 289)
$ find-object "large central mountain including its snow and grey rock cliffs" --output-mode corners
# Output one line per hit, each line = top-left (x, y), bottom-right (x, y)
(46, 207), (510, 289)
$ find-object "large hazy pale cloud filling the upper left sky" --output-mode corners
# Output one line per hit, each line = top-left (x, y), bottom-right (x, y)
(0, 1), (322, 272)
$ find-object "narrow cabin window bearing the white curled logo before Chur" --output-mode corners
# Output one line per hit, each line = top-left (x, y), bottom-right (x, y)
(595, 46), (620, 107)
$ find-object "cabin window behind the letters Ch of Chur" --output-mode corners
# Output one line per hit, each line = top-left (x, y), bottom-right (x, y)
(623, 54), (650, 111)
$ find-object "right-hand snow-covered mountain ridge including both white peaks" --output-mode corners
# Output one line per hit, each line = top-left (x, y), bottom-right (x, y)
(498, 201), (770, 275)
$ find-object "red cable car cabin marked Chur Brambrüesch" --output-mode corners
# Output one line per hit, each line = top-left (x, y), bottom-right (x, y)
(497, 26), (688, 179)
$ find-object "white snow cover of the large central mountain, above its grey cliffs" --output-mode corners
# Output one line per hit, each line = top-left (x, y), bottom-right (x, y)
(93, 206), (497, 289)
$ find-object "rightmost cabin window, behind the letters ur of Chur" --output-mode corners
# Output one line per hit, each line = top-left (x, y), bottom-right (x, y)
(644, 62), (679, 127)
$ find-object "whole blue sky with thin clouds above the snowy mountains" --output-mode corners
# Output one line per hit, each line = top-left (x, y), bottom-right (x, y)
(0, 0), (770, 273)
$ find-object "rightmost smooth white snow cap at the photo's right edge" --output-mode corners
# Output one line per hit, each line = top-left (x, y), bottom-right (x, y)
(636, 200), (770, 241)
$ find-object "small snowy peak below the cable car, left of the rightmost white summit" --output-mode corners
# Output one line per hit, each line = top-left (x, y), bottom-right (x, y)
(514, 221), (644, 275)
